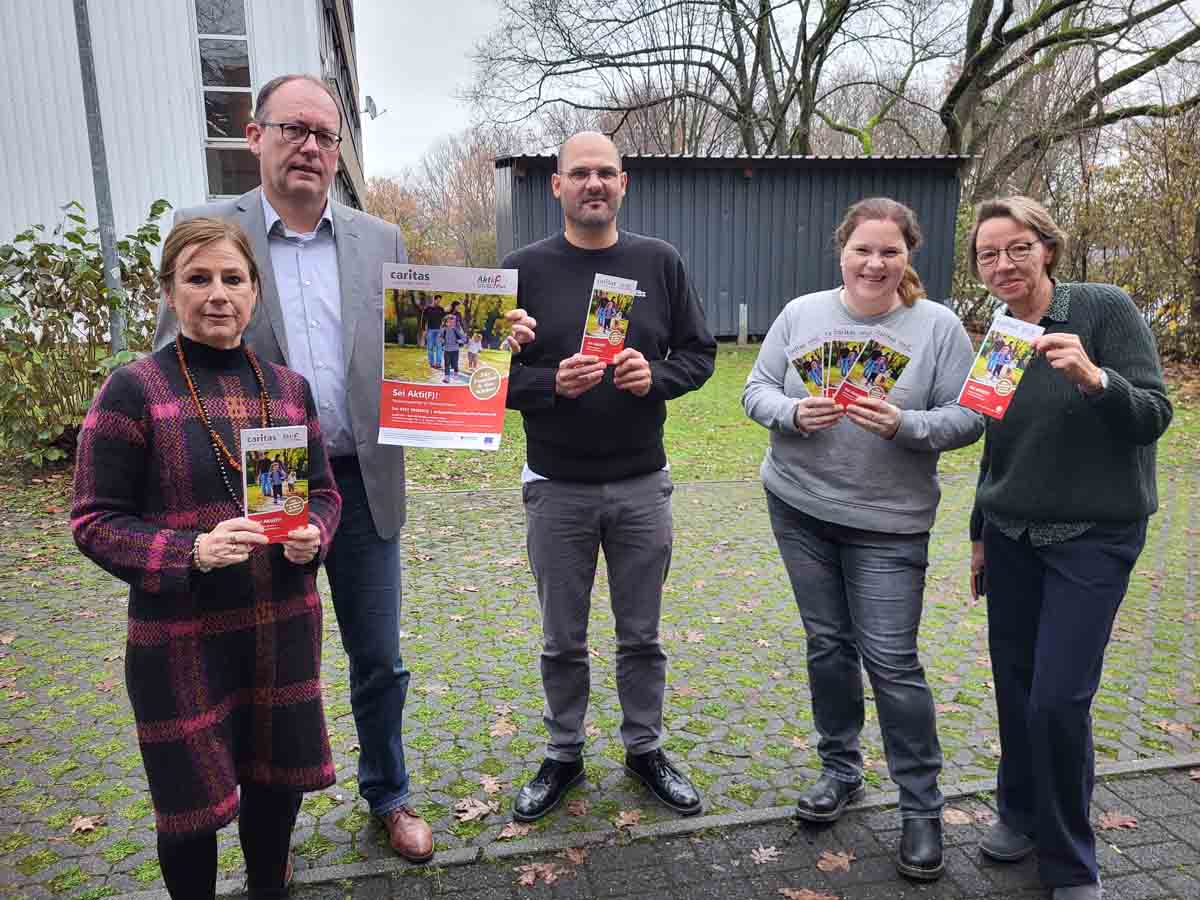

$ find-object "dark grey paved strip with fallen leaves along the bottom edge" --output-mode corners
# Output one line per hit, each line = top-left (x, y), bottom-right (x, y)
(255, 770), (1200, 900)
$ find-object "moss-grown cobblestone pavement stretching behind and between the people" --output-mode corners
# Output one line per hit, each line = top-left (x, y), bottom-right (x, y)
(0, 475), (1200, 898)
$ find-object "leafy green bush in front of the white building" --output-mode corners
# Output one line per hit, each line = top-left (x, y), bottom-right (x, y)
(0, 200), (170, 466)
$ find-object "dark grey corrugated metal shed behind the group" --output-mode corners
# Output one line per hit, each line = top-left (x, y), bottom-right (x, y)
(496, 155), (965, 336)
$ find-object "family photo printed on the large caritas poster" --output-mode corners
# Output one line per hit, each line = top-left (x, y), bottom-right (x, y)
(383, 288), (516, 384)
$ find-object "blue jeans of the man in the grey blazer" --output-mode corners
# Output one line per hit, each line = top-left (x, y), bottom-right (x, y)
(325, 456), (409, 815)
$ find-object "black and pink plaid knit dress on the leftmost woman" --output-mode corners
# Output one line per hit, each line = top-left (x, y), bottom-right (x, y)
(71, 337), (342, 835)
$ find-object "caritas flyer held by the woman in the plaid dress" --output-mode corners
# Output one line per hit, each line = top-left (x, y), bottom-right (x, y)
(241, 425), (308, 544)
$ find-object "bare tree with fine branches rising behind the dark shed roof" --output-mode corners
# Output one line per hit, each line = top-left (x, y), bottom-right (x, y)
(468, 0), (944, 154)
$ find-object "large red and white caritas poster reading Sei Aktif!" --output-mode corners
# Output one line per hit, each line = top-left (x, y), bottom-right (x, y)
(379, 264), (517, 450)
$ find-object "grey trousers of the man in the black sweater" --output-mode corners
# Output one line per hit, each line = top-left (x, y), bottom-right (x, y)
(522, 472), (674, 762)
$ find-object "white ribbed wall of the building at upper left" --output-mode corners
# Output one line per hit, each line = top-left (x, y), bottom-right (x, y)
(0, 0), (320, 241)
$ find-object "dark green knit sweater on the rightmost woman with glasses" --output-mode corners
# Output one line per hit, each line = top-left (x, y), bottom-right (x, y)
(971, 284), (1172, 540)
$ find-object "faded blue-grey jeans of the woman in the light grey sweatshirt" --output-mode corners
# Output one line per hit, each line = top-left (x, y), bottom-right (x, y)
(767, 491), (944, 818)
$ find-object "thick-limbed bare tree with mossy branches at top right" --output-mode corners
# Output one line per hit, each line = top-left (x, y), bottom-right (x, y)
(940, 0), (1200, 198)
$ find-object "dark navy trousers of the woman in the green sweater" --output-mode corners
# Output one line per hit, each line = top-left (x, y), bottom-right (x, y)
(983, 518), (1146, 888)
